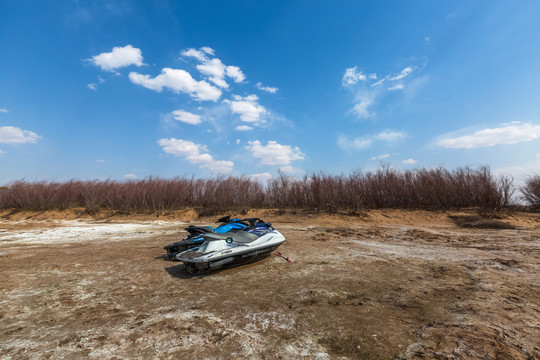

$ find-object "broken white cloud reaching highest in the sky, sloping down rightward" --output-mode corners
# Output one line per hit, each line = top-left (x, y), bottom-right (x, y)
(181, 46), (246, 89)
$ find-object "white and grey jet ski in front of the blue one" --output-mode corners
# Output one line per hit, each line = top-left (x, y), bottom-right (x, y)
(175, 218), (285, 274)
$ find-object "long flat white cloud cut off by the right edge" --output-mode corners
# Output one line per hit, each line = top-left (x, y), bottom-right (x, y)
(437, 123), (540, 149)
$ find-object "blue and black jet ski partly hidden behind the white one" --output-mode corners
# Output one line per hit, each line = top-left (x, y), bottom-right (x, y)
(165, 215), (249, 261)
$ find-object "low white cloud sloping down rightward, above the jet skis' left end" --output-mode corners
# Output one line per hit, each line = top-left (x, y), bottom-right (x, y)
(158, 138), (234, 173)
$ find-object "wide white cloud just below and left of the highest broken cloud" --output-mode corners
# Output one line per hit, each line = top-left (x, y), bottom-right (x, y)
(129, 68), (221, 101)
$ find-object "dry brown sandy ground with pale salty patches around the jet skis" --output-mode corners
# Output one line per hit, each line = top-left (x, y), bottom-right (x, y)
(0, 211), (540, 359)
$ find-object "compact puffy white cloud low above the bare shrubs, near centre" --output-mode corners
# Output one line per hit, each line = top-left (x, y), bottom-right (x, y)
(245, 140), (304, 166)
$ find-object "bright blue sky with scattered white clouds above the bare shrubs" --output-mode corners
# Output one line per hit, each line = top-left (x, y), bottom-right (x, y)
(0, 0), (540, 183)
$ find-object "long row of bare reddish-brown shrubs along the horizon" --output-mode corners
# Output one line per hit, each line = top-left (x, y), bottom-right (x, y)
(0, 167), (540, 213)
